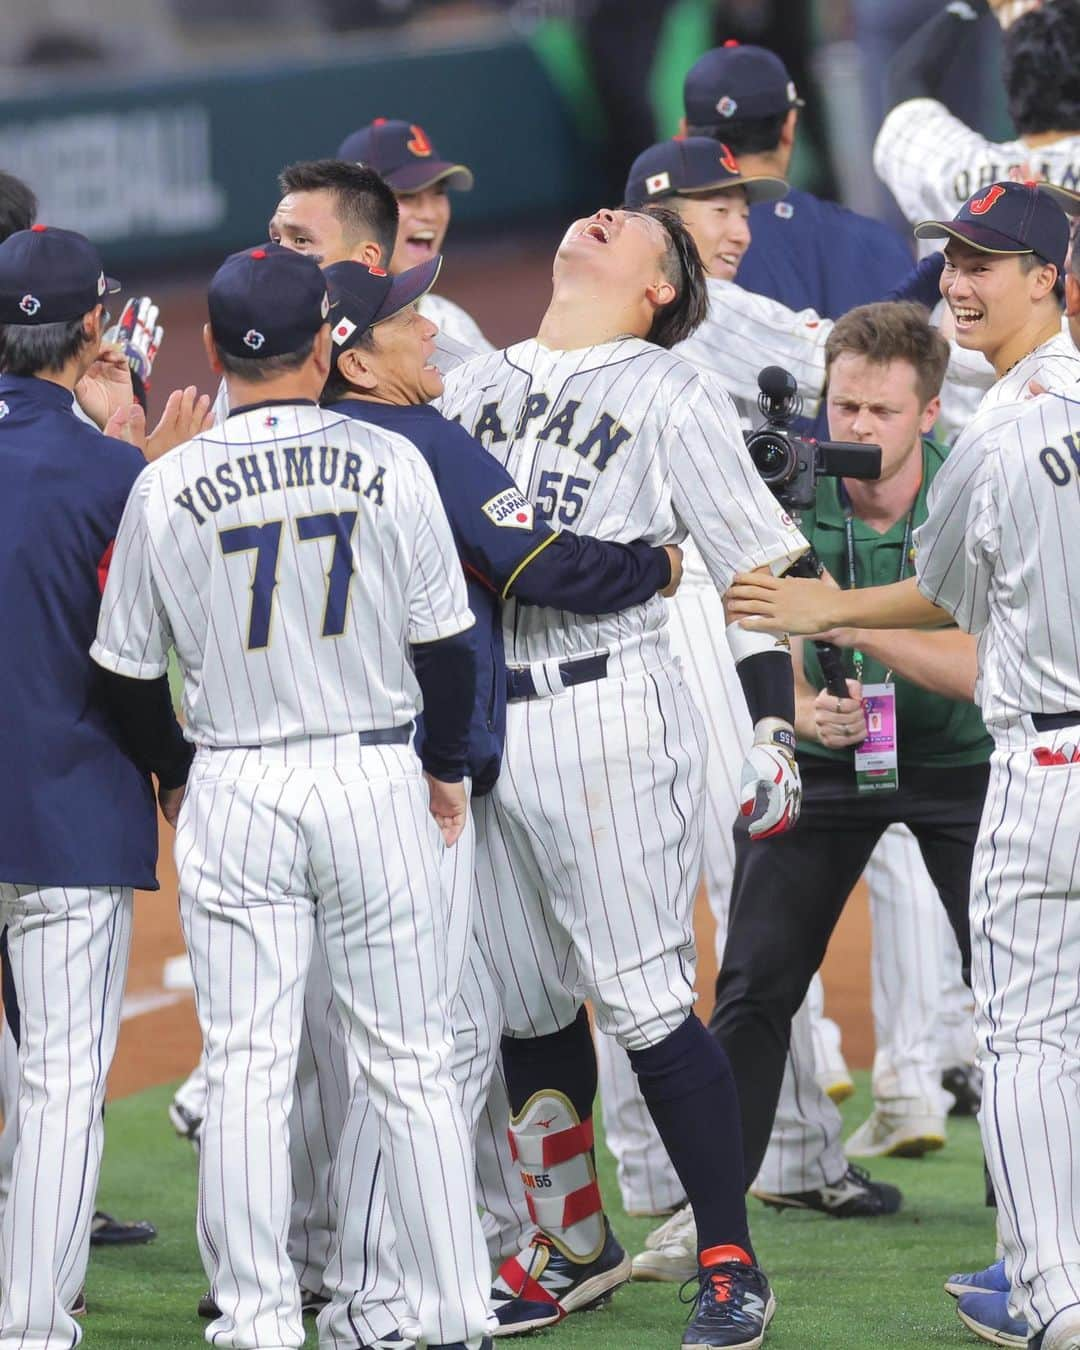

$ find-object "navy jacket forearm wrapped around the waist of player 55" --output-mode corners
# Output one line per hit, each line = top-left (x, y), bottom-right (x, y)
(508, 531), (671, 614)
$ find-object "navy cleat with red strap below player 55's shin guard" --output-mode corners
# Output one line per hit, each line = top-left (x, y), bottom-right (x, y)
(491, 1218), (630, 1337)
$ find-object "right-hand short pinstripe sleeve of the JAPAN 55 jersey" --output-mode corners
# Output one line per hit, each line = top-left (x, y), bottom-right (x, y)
(670, 374), (807, 591)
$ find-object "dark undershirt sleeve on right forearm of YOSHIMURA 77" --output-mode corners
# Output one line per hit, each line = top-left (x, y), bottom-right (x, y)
(412, 625), (477, 783)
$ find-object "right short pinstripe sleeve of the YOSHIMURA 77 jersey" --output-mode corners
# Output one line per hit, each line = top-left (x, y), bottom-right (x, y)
(408, 463), (475, 643)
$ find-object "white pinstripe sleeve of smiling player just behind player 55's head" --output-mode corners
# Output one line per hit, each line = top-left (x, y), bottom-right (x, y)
(676, 278), (833, 417)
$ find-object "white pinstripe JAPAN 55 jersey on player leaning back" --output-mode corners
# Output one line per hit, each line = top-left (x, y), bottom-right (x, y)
(441, 338), (806, 664)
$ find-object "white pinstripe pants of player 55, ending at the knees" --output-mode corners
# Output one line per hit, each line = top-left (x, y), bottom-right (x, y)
(475, 664), (705, 1049)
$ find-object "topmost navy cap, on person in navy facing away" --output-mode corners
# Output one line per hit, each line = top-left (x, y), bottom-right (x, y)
(683, 41), (803, 127)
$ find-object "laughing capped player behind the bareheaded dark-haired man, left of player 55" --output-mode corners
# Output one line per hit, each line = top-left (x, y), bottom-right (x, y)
(338, 117), (491, 369)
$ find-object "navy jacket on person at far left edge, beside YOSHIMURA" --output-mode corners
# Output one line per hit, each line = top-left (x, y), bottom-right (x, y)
(0, 375), (158, 890)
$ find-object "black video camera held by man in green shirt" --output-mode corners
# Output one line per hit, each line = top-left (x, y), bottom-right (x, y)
(747, 366), (882, 516)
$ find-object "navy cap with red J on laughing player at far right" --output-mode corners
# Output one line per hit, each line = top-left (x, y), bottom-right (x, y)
(915, 182), (1069, 275)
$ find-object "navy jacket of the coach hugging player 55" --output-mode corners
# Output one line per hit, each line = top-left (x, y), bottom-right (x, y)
(329, 398), (671, 795)
